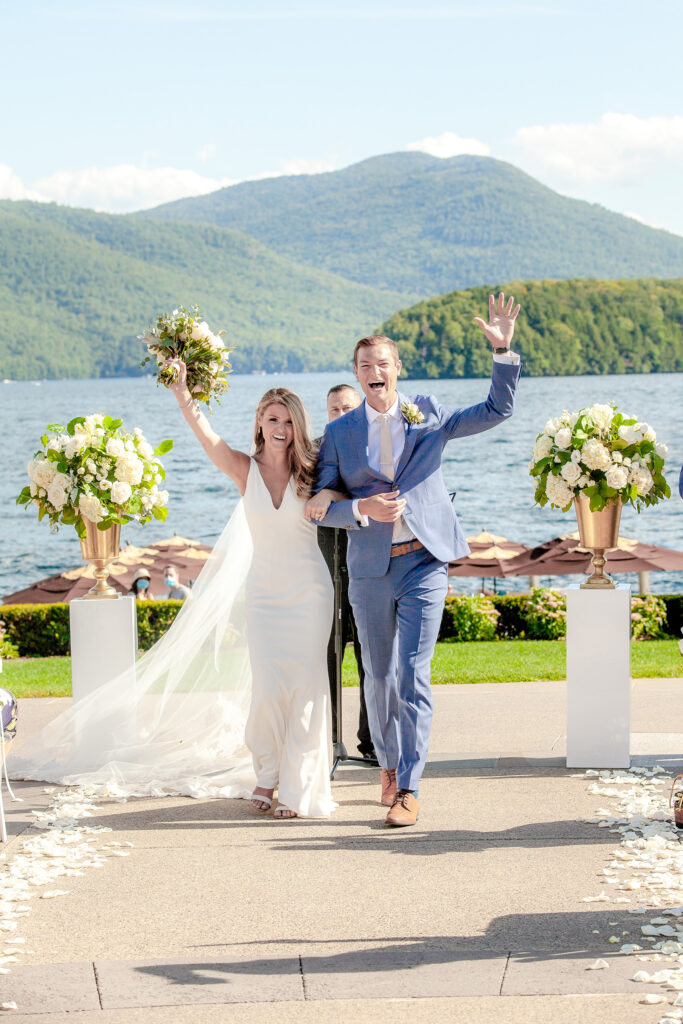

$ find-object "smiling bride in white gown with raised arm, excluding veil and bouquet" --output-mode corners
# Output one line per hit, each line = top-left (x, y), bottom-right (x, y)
(171, 372), (342, 818)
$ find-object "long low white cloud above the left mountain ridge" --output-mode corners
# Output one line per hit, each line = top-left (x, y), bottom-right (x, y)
(31, 164), (234, 213)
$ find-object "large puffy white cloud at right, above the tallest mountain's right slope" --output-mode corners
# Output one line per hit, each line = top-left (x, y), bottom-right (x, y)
(514, 114), (683, 184)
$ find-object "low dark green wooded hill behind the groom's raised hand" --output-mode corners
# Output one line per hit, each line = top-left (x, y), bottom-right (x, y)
(382, 278), (683, 378)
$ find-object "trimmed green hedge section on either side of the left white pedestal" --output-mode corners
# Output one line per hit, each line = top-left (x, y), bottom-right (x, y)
(0, 601), (182, 657)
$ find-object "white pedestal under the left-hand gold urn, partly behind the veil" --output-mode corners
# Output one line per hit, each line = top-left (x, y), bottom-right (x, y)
(69, 597), (137, 752)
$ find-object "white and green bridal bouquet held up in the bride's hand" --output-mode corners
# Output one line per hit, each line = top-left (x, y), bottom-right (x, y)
(139, 306), (232, 406)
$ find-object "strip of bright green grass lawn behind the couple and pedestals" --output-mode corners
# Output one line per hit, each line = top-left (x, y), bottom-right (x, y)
(6, 640), (683, 697)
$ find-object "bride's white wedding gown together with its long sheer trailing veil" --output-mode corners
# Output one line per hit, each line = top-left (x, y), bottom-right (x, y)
(12, 460), (336, 817)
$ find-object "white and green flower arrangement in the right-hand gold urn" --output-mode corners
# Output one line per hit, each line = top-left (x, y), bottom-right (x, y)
(529, 404), (671, 512)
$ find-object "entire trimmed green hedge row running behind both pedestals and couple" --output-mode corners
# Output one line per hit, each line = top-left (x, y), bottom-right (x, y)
(0, 594), (683, 657)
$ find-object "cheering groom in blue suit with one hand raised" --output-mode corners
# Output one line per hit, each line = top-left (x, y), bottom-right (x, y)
(316, 293), (520, 826)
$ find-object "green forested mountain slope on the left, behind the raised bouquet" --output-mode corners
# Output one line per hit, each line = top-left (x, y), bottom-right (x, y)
(0, 201), (417, 379)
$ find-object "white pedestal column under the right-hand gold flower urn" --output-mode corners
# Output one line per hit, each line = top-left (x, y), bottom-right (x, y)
(567, 584), (631, 768)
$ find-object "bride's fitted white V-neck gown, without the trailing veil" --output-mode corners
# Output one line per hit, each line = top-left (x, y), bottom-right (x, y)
(244, 459), (334, 817)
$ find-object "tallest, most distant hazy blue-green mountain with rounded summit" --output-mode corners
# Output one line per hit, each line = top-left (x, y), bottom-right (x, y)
(143, 153), (683, 297)
